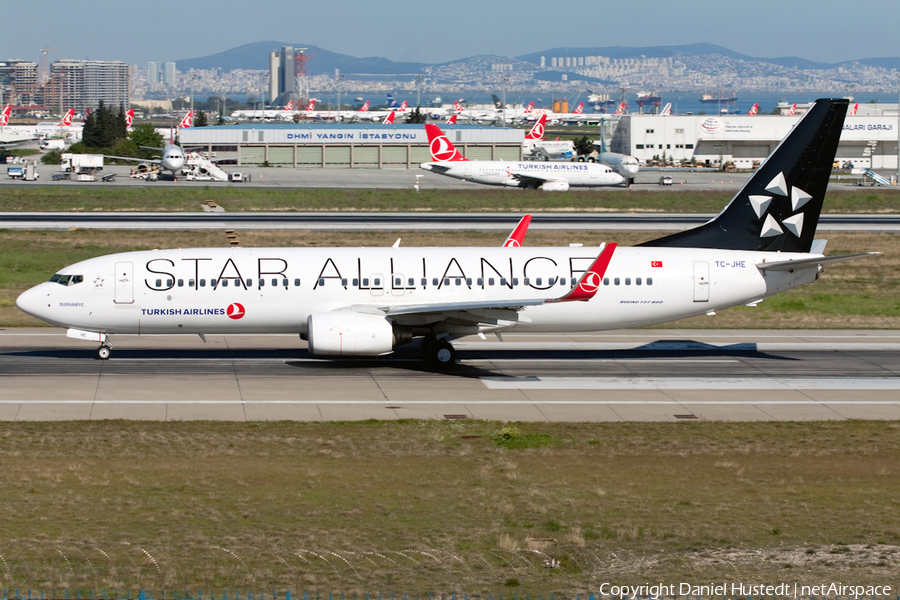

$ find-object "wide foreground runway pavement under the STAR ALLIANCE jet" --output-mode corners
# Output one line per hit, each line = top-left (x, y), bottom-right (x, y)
(0, 328), (900, 421)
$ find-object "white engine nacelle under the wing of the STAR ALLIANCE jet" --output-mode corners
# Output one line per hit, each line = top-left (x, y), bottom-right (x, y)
(306, 310), (394, 356)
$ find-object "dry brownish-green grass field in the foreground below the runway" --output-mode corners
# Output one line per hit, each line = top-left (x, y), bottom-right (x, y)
(0, 421), (900, 597)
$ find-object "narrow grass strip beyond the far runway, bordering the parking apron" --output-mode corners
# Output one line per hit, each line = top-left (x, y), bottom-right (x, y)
(0, 186), (900, 213)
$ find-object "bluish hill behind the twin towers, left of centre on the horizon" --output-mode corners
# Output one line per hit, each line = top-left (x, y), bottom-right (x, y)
(177, 41), (428, 75)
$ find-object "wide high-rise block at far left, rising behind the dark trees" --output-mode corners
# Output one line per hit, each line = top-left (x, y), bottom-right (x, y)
(42, 60), (131, 112)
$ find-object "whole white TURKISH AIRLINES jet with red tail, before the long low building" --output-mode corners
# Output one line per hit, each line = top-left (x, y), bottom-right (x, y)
(419, 123), (624, 192)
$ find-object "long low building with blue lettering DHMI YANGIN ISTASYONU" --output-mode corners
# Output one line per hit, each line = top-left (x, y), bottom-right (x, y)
(179, 123), (525, 169)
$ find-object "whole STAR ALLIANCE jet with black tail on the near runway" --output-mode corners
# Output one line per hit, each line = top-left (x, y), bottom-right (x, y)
(16, 100), (871, 363)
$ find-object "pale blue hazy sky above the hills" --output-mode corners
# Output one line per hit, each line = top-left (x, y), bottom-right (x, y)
(0, 0), (900, 64)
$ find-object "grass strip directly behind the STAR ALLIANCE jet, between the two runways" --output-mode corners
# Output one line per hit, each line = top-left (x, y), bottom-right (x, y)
(0, 230), (900, 329)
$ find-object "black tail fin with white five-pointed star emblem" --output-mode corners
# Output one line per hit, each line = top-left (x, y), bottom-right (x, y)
(640, 99), (850, 252)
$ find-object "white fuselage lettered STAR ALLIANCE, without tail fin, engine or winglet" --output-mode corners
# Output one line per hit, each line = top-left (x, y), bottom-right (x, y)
(17, 247), (819, 335)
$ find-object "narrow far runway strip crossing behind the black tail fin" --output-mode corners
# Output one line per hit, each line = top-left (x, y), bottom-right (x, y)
(0, 212), (900, 232)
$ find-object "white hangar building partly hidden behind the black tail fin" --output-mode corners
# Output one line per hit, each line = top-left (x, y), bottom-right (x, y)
(610, 109), (898, 170)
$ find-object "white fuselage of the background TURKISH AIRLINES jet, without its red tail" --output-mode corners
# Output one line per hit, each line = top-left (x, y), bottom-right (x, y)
(419, 160), (624, 187)
